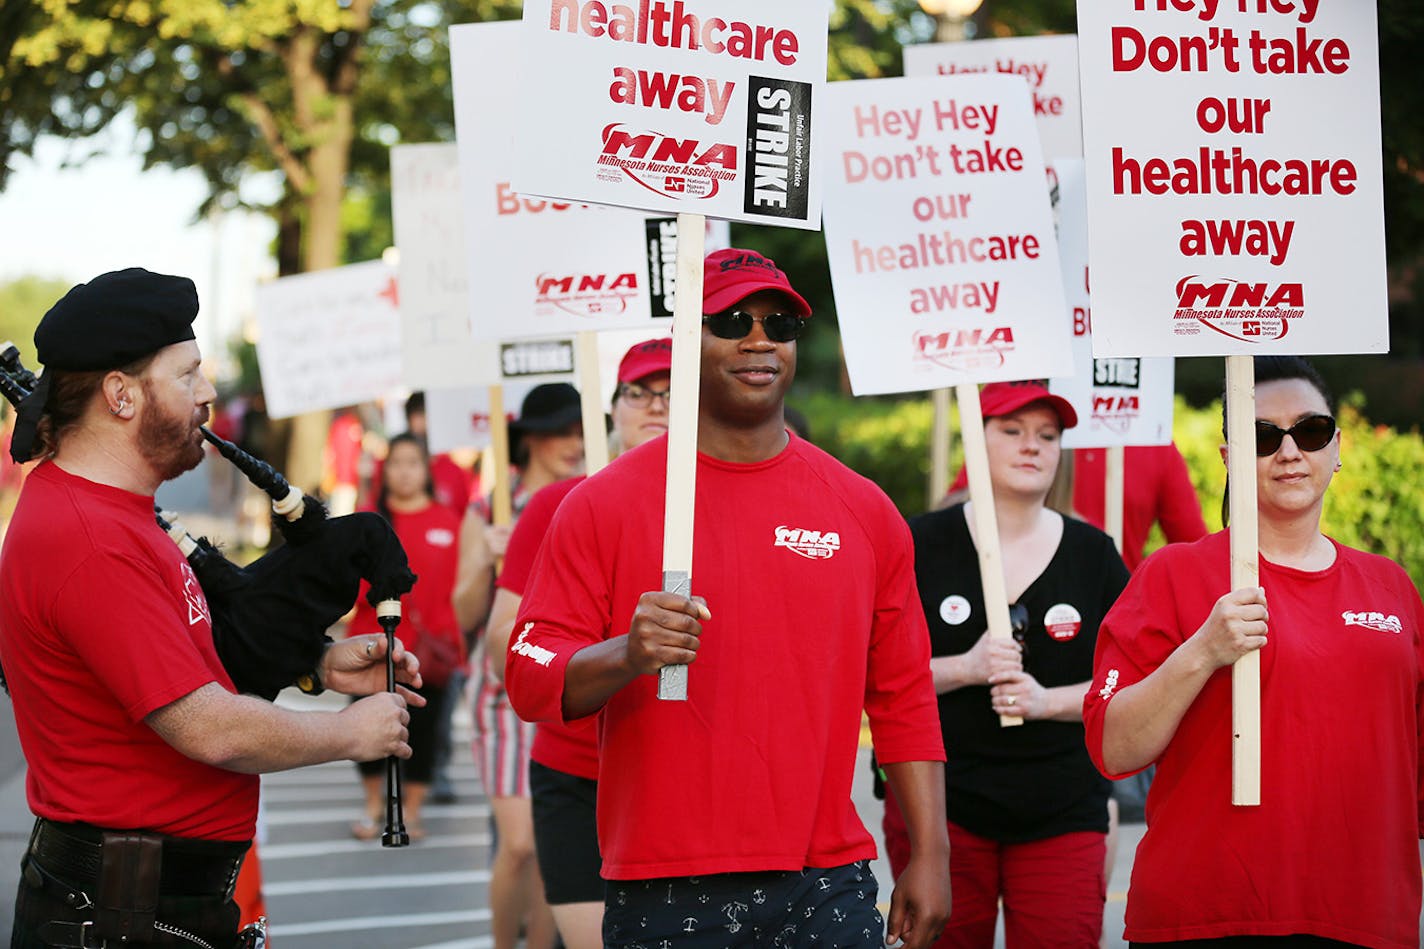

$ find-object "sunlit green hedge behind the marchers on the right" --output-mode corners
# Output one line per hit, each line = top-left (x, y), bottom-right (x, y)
(793, 393), (1424, 586)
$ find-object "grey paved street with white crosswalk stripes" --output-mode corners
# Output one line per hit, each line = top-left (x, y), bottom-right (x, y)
(0, 669), (1412, 949)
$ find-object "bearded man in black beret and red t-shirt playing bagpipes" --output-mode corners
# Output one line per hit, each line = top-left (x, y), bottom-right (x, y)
(0, 268), (423, 949)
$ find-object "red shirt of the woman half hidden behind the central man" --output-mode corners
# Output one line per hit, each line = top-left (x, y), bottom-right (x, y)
(494, 475), (598, 781)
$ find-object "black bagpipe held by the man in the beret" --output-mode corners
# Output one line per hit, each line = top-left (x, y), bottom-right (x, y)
(0, 342), (416, 846)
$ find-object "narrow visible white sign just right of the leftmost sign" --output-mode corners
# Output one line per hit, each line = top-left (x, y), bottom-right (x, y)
(390, 144), (487, 389)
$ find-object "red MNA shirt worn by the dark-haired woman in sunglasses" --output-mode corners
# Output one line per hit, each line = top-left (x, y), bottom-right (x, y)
(1084, 531), (1424, 946)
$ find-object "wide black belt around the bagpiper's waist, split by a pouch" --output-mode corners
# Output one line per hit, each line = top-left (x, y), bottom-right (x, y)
(30, 818), (248, 898)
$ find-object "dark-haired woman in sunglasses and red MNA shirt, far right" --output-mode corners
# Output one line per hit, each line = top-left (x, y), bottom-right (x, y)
(1084, 356), (1424, 946)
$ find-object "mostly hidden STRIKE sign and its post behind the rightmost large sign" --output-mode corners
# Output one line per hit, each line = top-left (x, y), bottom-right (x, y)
(1048, 158), (1173, 553)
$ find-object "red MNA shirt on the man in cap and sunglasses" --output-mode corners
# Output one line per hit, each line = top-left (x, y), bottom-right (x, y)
(506, 436), (944, 879)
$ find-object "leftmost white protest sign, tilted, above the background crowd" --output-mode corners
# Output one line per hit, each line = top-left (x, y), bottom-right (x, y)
(256, 261), (402, 419)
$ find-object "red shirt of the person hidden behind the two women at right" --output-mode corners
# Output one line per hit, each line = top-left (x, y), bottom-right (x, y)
(950, 445), (1206, 570)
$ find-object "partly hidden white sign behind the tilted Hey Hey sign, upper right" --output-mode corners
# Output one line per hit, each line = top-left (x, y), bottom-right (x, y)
(904, 36), (1082, 161)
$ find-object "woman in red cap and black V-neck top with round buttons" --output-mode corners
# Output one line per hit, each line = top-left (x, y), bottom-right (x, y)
(886, 382), (1128, 949)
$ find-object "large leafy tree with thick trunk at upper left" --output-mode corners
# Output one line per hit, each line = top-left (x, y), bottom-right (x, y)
(0, 0), (518, 487)
